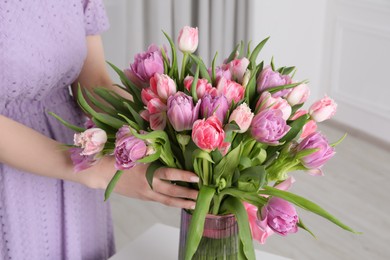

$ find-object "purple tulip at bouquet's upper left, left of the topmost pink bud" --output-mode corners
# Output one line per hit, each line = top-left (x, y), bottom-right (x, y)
(125, 44), (164, 83)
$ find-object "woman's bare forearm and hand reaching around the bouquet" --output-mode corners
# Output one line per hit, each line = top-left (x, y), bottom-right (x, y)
(0, 115), (197, 208)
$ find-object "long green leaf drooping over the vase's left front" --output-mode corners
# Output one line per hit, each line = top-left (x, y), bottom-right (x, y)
(185, 185), (215, 260)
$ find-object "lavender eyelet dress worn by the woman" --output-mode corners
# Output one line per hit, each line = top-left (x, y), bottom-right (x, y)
(0, 0), (114, 260)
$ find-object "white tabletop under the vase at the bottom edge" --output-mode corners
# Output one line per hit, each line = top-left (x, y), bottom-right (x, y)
(109, 224), (291, 260)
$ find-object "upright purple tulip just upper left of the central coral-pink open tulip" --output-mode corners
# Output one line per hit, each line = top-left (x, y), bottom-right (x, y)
(167, 92), (201, 132)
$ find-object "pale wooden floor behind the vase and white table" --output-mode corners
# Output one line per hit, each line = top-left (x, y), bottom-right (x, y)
(111, 126), (390, 260)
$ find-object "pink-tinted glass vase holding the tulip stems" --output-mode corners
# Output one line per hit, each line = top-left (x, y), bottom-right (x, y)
(179, 209), (239, 260)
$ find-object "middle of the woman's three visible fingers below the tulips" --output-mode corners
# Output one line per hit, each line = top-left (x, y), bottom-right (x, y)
(153, 179), (198, 200)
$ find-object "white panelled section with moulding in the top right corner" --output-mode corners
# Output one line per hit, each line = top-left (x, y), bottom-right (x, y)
(322, 0), (390, 143)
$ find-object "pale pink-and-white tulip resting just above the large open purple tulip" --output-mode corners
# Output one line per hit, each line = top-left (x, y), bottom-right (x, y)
(256, 91), (292, 120)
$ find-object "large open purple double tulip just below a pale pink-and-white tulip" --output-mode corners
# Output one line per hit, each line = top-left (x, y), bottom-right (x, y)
(251, 109), (291, 145)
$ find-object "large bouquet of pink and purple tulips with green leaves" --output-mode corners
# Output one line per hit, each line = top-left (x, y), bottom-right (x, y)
(51, 26), (354, 259)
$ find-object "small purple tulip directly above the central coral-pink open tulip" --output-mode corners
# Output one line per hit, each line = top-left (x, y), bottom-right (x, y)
(200, 94), (229, 123)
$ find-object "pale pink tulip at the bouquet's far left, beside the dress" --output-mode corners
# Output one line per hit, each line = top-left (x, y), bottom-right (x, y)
(74, 128), (107, 155)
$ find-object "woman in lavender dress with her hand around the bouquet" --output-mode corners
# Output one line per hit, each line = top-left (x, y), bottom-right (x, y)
(0, 0), (197, 260)
